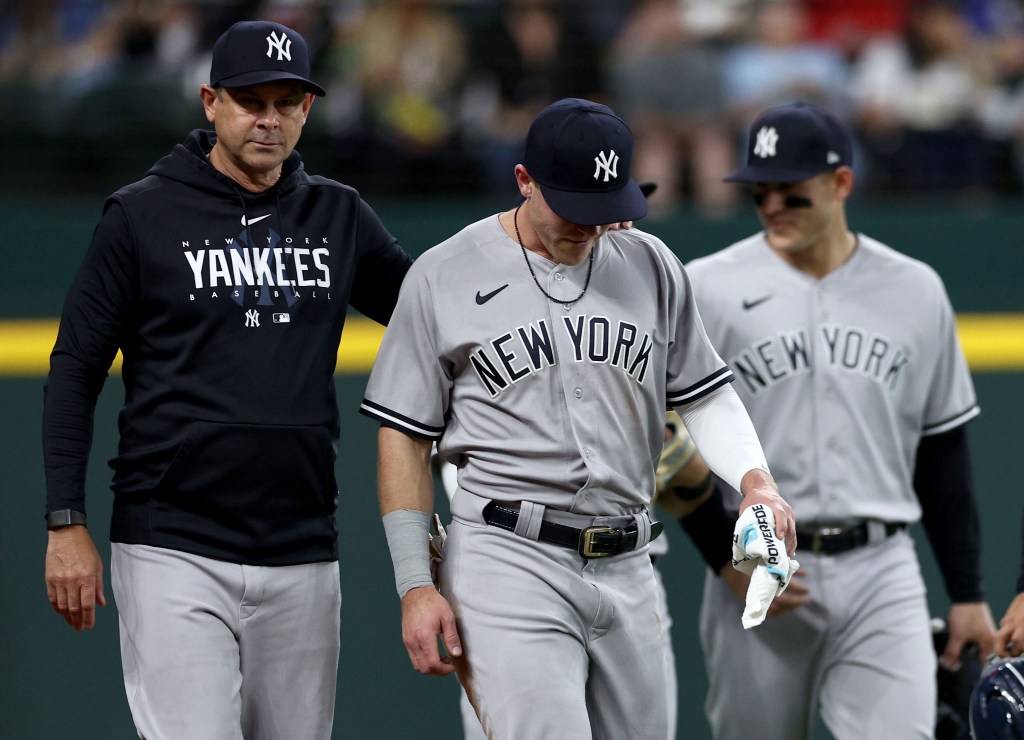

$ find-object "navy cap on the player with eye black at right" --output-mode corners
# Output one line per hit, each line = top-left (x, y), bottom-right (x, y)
(725, 102), (853, 182)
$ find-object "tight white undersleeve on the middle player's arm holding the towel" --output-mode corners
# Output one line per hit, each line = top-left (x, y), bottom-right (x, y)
(676, 385), (768, 492)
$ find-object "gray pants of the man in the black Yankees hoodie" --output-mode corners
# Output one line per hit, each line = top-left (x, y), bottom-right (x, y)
(111, 542), (341, 740)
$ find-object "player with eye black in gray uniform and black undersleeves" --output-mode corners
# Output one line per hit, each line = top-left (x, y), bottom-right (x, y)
(687, 103), (994, 740)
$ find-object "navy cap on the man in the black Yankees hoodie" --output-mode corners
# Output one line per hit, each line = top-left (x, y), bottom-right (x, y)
(210, 20), (327, 95)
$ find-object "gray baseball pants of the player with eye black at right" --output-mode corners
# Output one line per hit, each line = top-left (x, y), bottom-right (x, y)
(700, 532), (936, 740)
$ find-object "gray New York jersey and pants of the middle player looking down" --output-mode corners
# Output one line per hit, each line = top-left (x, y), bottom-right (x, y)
(360, 216), (732, 740)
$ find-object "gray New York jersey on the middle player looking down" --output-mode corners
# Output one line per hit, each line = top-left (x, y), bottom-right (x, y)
(361, 216), (732, 515)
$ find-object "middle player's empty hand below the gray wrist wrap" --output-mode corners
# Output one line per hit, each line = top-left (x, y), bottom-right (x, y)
(401, 585), (462, 676)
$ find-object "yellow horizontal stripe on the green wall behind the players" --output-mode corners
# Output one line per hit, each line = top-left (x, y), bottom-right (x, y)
(6, 313), (1024, 377)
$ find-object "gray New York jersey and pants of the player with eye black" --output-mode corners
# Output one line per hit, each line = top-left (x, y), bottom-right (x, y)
(687, 234), (978, 738)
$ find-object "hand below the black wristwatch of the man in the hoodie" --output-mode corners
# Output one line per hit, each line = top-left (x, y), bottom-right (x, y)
(45, 524), (106, 632)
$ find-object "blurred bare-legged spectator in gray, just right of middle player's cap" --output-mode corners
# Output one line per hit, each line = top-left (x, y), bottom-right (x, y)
(607, 0), (737, 216)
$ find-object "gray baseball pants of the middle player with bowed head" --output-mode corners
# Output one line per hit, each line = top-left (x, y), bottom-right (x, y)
(441, 490), (668, 740)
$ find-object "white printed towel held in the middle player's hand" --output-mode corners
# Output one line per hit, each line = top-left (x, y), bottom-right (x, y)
(732, 504), (800, 629)
